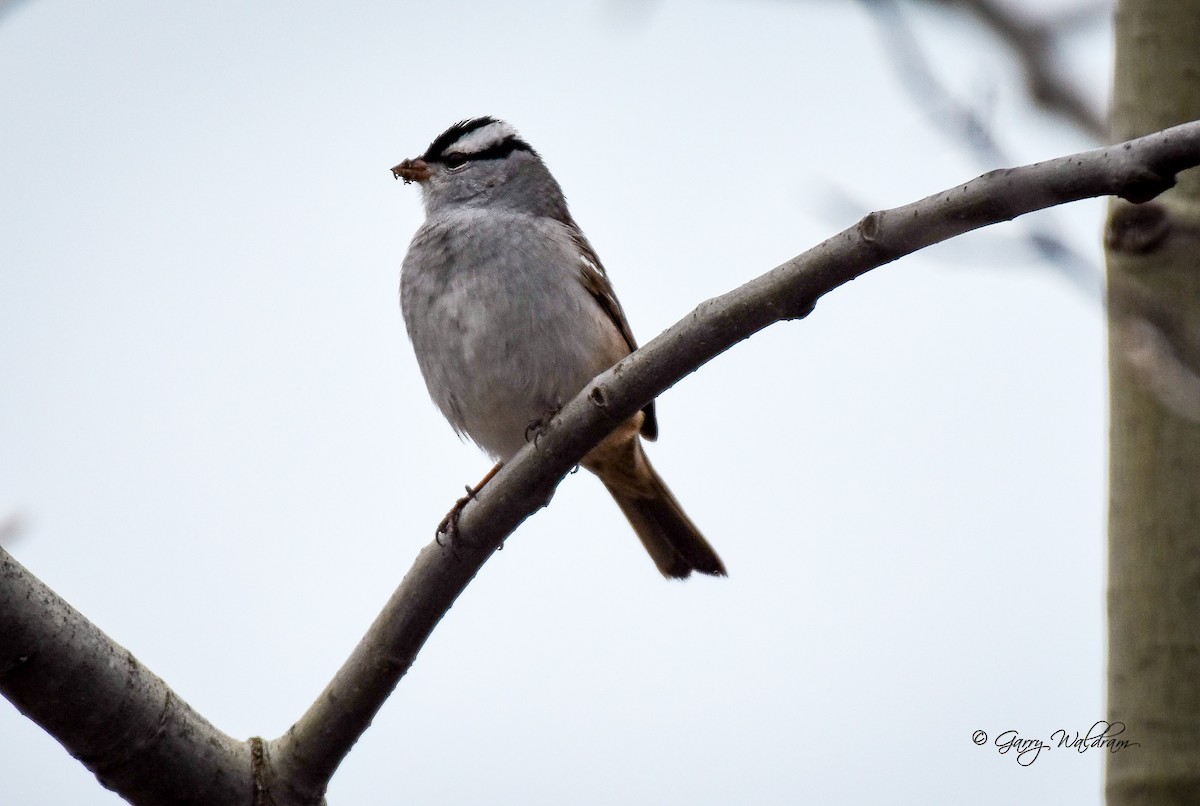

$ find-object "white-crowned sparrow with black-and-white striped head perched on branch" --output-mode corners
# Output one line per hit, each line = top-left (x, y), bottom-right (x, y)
(391, 116), (726, 579)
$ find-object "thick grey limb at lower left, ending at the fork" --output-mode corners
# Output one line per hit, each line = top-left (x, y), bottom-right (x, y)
(0, 548), (253, 806)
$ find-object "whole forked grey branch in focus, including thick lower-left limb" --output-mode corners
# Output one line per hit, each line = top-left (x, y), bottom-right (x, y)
(0, 121), (1200, 805)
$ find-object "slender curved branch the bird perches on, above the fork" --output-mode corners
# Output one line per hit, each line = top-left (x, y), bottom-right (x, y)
(269, 121), (1200, 798)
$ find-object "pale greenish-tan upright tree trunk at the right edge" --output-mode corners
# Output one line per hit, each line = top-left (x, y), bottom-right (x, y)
(1105, 0), (1200, 806)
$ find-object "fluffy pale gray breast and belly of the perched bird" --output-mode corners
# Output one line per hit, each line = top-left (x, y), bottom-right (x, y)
(401, 210), (629, 461)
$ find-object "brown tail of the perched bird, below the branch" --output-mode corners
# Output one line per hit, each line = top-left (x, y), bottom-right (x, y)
(584, 432), (726, 579)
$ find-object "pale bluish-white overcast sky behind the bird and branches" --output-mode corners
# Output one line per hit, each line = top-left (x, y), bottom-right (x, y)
(0, 0), (1113, 806)
